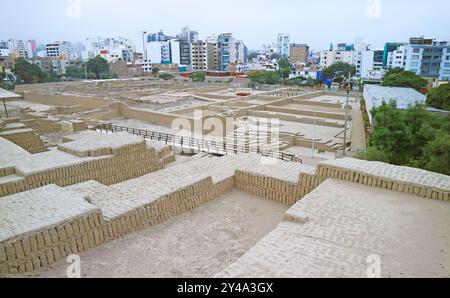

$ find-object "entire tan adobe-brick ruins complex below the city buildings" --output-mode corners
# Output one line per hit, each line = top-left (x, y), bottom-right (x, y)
(0, 79), (450, 278)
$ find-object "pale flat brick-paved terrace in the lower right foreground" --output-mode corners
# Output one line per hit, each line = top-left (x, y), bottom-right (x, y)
(217, 179), (450, 278)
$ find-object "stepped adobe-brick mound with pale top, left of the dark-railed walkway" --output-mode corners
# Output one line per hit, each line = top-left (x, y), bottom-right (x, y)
(0, 131), (174, 197)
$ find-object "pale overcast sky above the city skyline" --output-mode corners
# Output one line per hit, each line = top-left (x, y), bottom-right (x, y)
(0, 0), (450, 50)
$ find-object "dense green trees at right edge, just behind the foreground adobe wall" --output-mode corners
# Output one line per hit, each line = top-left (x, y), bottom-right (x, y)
(356, 101), (450, 175)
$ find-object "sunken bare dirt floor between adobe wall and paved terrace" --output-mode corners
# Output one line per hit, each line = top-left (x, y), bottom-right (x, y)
(17, 190), (289, 278)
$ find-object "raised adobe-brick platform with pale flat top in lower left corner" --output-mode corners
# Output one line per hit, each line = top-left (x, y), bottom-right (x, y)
(0, 185), (104, 274)
